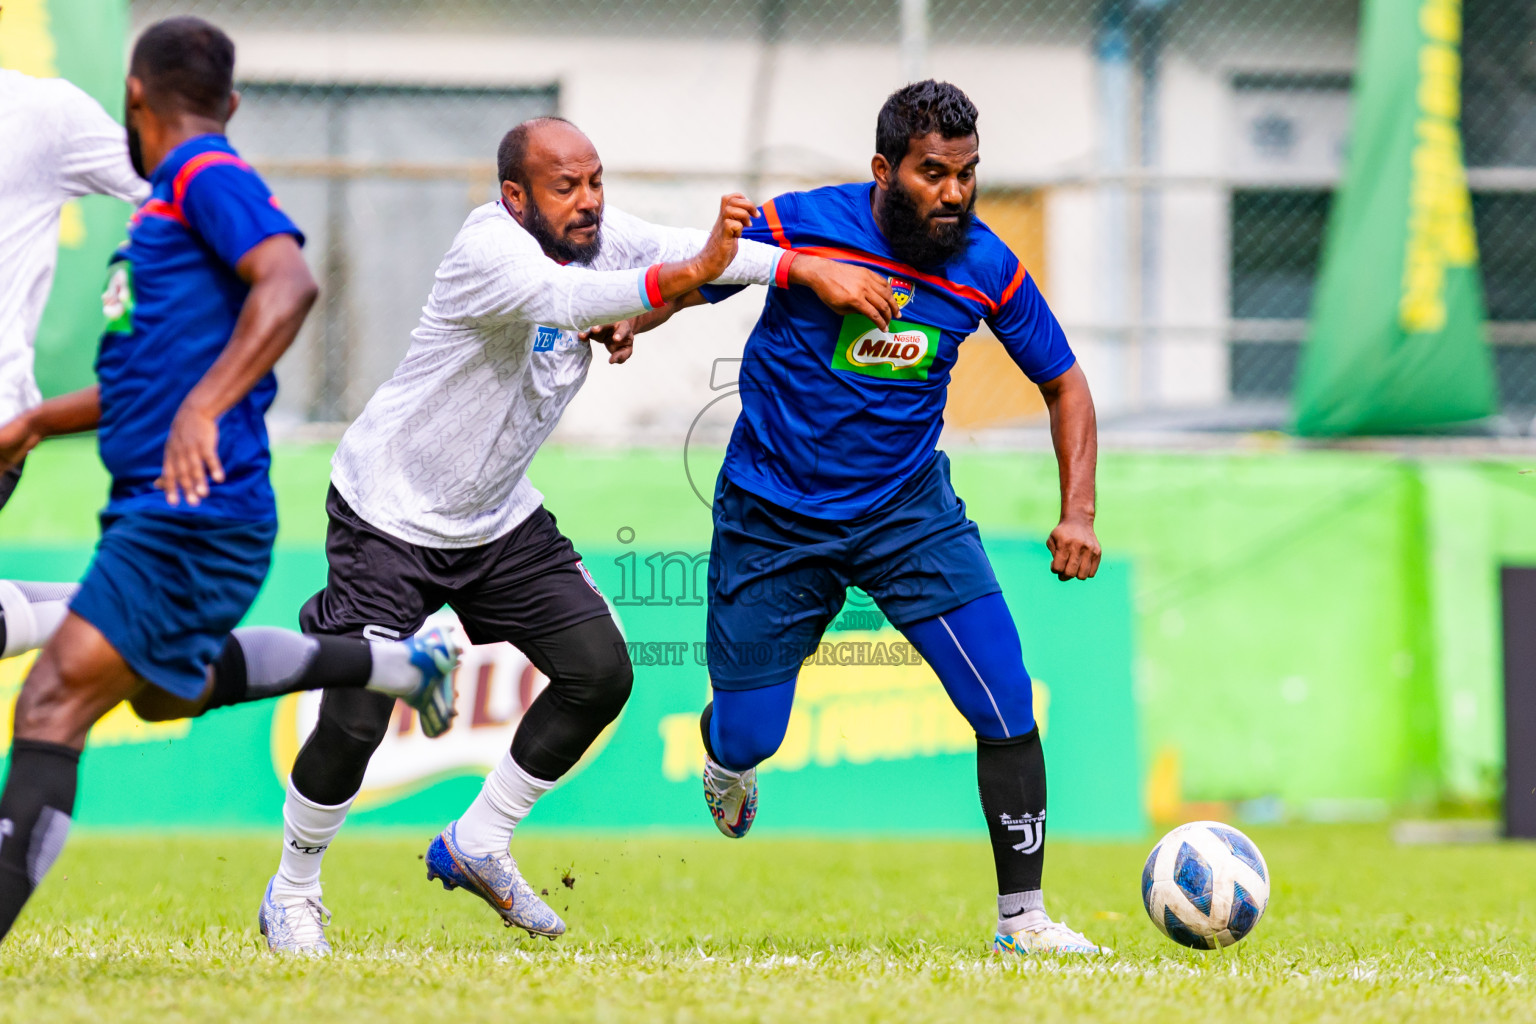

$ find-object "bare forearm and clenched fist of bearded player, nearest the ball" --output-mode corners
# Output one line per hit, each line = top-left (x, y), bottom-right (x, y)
(1040, 362), (1103, 580)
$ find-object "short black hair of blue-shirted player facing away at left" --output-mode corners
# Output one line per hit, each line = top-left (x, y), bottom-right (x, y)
(127, 17), (235, 121)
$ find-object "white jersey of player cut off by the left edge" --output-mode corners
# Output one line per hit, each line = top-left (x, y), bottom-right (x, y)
(0, 69), (149, 422)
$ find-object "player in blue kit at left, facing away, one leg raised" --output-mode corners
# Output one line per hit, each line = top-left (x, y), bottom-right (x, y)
(0, 18), (456, 938)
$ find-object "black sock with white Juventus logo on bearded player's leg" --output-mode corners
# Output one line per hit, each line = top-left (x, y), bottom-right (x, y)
(975, 726), (1046, 918)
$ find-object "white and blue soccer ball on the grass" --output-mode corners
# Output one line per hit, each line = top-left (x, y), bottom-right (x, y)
(1141, 821), (1269, 949)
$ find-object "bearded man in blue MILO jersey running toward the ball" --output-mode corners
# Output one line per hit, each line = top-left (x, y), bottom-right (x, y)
(620, 81), (1109, 953)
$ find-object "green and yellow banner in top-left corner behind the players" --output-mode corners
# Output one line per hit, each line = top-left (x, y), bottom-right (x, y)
(0, 0), (132, 395)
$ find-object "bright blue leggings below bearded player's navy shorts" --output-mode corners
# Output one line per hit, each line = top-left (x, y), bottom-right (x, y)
(710, 594), (1035, 771)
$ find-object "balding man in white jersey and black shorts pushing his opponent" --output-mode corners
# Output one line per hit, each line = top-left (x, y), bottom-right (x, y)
(261, 118), (895, 953)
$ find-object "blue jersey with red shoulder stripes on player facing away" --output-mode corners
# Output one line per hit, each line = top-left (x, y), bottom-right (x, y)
(95, 135), (304, 520)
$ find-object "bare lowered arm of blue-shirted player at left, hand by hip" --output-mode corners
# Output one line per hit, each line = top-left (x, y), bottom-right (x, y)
(157, 235), (319, 505)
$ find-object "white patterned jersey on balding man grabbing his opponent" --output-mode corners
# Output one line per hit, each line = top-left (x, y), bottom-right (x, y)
(330, 203), (786, 548)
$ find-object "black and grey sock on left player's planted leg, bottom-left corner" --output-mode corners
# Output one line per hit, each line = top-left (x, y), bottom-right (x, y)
(0, 740), (80, 940)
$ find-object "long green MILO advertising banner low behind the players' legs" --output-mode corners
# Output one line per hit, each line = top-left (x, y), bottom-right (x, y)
(0, 539), (1146, 837)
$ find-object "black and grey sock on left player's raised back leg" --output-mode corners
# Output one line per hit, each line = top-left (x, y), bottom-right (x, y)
(203, 626), (376, 711)
